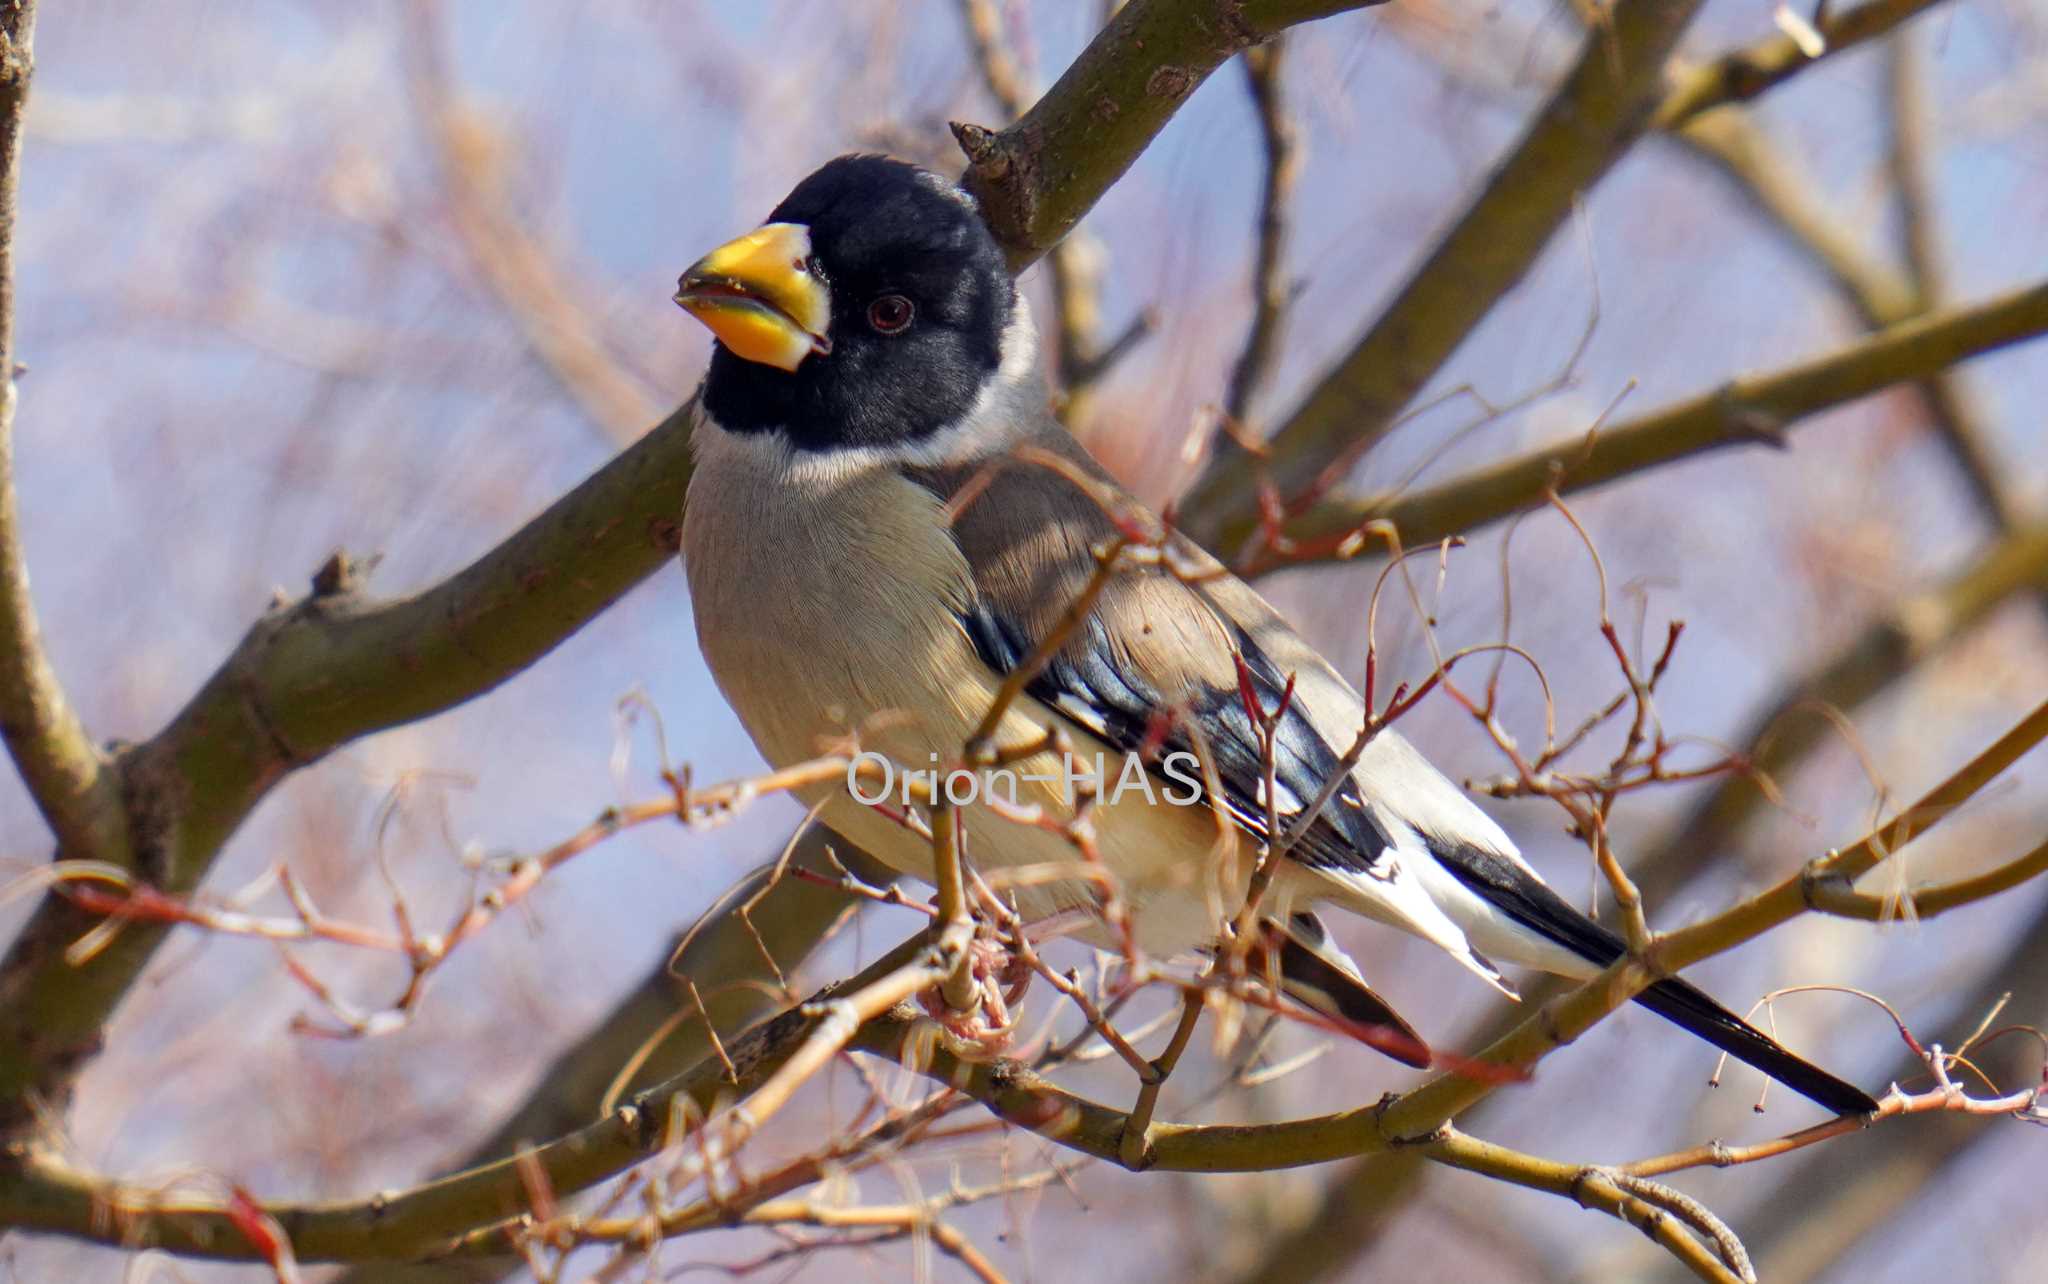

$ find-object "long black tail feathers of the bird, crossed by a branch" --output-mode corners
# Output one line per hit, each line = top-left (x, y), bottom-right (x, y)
(1430, 844), (1878, 1114)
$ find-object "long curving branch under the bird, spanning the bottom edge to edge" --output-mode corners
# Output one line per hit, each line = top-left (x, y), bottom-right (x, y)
(16, 704), (2048, 1259)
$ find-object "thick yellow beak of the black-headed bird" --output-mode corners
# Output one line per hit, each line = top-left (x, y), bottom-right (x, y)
(676, 223), (831, 371)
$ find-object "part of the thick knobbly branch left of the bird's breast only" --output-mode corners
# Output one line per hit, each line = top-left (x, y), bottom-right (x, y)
(0, 405), (690, 1135)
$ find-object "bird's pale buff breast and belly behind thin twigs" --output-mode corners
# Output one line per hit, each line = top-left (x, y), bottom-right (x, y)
(684, 417), (1247, 954)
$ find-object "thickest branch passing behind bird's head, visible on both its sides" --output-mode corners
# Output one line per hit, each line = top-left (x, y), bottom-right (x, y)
(0, 0), (1358, 1137)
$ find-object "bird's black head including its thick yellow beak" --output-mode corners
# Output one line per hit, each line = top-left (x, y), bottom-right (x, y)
(676, 156), (1016, 451)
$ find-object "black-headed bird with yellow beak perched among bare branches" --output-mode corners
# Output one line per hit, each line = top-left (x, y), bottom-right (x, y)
(676, 154), (1876, 1114)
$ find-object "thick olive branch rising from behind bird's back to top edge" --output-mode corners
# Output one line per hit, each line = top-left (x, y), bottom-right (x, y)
(1180, 0), (1700, 549)
